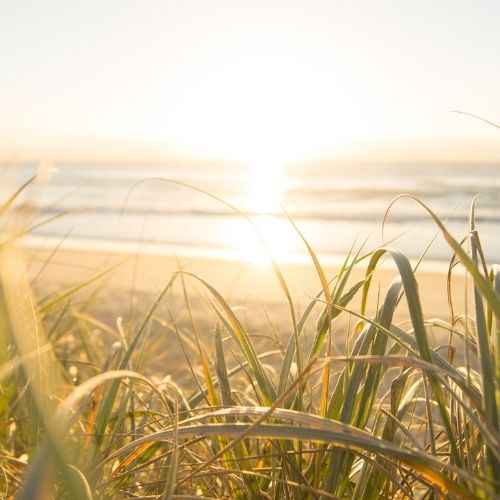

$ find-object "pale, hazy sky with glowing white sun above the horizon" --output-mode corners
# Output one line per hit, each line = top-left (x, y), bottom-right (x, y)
(0, 0), (500, 161)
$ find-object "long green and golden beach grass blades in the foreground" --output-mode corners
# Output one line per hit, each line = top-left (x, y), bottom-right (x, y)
(0, 179), (500, 499)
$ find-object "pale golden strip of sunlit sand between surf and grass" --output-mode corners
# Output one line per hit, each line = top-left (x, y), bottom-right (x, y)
(26, 240), (464, 320)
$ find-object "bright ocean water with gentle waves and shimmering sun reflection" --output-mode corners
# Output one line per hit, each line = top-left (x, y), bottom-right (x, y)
(0, 161), (500, 263)
